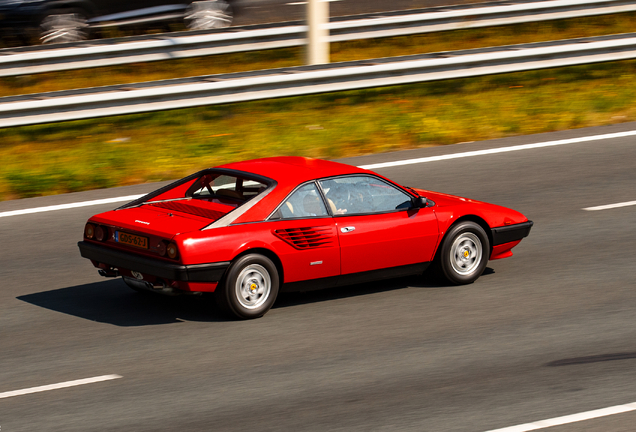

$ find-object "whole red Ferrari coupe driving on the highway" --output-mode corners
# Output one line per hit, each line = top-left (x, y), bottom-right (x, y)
(79, 157), (532, 318)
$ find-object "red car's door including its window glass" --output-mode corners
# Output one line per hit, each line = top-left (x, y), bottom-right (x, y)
(320, 175), (438, 275)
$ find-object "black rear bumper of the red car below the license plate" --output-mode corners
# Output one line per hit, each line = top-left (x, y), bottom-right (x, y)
(77, 241), (230, 282)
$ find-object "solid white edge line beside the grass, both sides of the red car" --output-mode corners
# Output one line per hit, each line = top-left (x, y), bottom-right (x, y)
(0, 130), (636, 217)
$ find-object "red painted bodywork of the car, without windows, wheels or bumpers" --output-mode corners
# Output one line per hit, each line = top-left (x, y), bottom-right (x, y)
(80, 157), (528, 291)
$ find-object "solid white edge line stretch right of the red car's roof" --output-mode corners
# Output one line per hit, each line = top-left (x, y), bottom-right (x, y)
(359, 131), (636, 170)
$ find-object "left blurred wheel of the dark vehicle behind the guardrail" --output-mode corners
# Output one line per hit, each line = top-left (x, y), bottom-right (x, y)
(40, 9), (88, 44)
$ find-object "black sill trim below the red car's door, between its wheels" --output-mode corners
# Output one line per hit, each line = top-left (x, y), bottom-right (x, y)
(281, 262), (430, 292)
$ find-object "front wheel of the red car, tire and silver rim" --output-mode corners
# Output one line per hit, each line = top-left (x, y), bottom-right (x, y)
(434, 221), (490, 285)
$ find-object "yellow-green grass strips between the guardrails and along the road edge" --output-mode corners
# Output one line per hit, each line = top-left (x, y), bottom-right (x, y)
(0, 14), (636, 200)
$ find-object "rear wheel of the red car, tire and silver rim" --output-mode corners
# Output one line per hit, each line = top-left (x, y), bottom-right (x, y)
(215, 254), (279, 319)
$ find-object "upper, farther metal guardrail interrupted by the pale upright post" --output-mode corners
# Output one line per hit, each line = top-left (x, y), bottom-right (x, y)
(0, 0), (636, 76)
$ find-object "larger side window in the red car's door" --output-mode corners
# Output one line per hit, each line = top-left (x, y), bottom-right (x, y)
(320, 176), (411, 215)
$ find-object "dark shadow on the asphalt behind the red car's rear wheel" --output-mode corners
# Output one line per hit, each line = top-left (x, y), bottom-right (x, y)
(18, 279), (227, 327)
